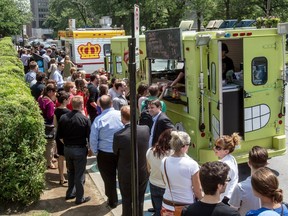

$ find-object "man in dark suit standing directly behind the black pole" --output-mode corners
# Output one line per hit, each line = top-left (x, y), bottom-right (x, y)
(113, 106), (149, 216)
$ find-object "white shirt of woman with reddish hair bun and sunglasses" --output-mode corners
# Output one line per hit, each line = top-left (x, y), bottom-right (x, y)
(220, 154), (239, 200)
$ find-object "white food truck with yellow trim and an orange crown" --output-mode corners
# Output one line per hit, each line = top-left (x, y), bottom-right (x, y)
(58, 29), (125, 74)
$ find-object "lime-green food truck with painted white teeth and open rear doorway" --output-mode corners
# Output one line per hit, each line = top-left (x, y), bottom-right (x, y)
(111, 24), (288, 164)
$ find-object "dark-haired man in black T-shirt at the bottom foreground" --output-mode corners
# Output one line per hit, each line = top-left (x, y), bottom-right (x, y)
(181, 161), (240, 216)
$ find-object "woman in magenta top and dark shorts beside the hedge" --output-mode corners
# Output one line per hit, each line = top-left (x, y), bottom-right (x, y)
(38, 84), (57, 169)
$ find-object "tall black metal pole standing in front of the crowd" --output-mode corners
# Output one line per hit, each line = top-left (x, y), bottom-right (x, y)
(128, 9), (139, 216)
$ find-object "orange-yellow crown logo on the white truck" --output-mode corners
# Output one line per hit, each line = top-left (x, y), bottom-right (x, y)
(77, 42), (101, 59)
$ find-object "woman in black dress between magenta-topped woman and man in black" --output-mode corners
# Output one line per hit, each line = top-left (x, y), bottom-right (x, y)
(53, 91), (70, 185)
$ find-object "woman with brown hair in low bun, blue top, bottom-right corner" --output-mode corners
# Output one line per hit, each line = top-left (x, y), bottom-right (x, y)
(246, 167), (288, 216)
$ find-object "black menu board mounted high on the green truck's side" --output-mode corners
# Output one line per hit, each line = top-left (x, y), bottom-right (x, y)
(145, 28), (182, 60)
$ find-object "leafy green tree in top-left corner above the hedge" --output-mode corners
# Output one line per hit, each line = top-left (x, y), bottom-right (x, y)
(0, 0), (32, 36)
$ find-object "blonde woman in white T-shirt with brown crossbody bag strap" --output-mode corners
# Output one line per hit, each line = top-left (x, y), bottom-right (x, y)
(161, 131), (202, 216)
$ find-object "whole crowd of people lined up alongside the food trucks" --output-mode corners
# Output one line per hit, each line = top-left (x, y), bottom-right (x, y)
(20, 46), (288, 216)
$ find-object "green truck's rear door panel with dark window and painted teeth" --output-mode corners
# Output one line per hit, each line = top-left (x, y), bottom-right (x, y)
(243, 35), (282, 141)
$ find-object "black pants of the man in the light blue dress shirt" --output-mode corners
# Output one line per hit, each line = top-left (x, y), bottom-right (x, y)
(97, 151), (118, 205)
